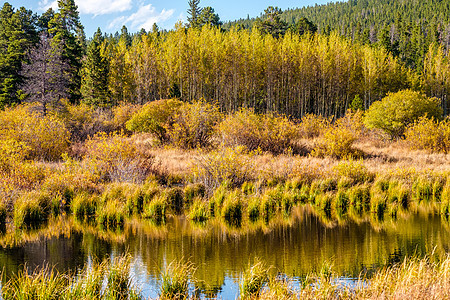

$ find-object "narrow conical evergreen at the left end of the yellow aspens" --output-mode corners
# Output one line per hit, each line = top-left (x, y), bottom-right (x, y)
(81, 28), (110, 106)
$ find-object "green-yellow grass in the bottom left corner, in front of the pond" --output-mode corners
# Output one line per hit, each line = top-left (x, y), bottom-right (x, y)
(2, 254), (143, 300)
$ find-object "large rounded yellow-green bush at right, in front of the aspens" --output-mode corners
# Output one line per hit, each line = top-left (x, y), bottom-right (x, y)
(364, 90), (442, 138)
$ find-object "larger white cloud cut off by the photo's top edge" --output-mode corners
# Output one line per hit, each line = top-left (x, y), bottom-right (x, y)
(75, 0), (132, 15)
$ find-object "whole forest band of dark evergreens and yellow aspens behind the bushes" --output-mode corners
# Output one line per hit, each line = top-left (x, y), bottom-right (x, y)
(0, 0), (450, 117)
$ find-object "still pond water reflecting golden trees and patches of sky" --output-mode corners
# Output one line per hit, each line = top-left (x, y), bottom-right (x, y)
(0, 208), (450, 299)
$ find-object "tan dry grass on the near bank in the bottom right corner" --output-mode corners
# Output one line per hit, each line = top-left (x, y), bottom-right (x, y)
(259, 256), (450, 300)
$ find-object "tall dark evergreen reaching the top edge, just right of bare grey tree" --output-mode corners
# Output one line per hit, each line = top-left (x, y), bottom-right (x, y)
(49, 0), (86, 102)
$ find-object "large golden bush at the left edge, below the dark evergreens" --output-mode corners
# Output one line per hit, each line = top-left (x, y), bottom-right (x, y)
(0, 105), (70, 160)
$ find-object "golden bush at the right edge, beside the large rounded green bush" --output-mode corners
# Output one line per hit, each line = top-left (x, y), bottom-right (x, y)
(405, 117), (450, 153)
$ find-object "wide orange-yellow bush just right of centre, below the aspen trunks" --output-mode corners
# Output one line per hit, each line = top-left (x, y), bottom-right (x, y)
(218, 109), (300, 154)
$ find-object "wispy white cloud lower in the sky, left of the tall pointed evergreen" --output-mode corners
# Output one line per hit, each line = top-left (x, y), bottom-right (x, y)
(108, 4), (175, 30)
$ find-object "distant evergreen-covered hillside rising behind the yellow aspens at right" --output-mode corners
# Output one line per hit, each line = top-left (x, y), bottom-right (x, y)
(224, 0), (450, 70)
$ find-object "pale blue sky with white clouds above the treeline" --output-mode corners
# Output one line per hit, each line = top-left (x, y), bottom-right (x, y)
(7, 0), (328, 37)
